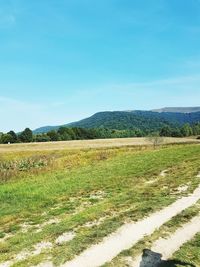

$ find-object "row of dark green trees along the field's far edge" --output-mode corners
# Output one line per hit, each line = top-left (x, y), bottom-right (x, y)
(0, 123), (200, 144)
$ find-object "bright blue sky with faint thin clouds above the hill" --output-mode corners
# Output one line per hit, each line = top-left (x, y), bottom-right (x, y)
(0, 0), (200, 131)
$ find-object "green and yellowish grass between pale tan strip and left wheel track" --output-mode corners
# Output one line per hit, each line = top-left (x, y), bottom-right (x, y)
(0, 145), (200, 266)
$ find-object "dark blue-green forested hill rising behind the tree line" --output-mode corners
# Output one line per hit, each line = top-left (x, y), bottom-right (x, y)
(34, 111), (200, 133)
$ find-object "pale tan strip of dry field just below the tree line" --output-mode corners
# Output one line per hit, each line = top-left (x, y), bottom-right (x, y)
(0, 137), (200, 153)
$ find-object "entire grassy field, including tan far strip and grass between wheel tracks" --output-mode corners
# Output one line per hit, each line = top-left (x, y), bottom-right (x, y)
(0, 139), (200, 267)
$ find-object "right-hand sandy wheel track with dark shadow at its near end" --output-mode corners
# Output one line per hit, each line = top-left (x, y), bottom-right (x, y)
(129, 216), (200, 267)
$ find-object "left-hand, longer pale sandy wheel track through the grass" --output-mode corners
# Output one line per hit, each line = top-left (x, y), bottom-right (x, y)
(62, 186), (200, 267)
